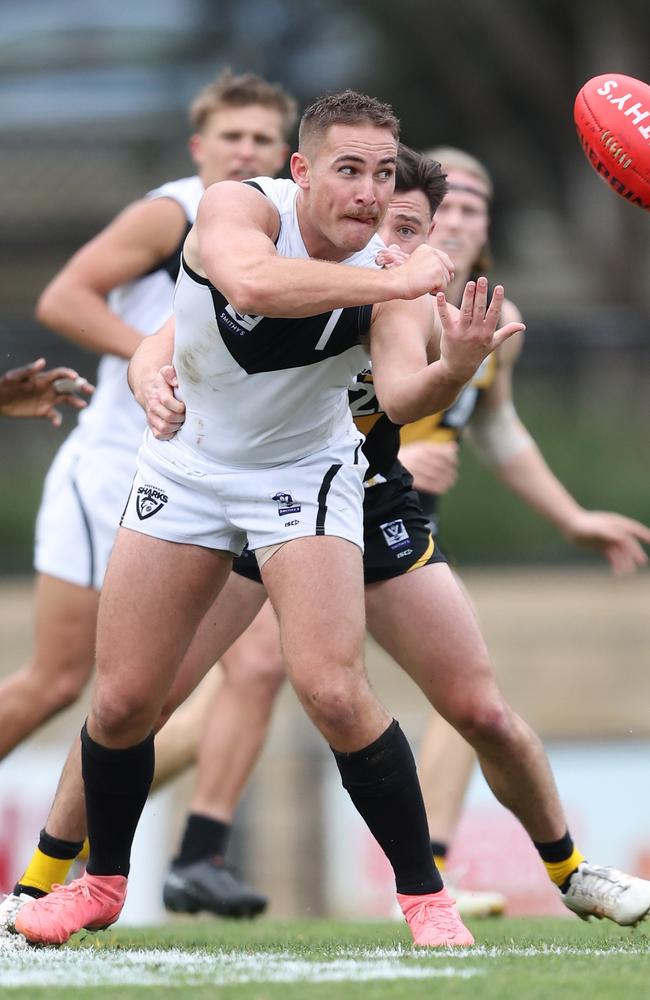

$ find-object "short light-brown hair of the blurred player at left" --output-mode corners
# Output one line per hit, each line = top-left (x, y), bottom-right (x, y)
(190, 69), (298, 139)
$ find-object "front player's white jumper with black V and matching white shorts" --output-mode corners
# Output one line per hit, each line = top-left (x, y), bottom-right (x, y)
(122, 178), (383, 554)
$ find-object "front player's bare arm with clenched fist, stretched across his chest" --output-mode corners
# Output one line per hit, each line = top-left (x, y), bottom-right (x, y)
(185, 181), (453, 318)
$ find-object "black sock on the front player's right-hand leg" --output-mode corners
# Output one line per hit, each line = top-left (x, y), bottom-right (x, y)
(332, 719), (442, 896)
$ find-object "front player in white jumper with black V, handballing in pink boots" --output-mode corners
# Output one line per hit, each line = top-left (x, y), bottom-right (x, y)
(16, 92), (520, 945)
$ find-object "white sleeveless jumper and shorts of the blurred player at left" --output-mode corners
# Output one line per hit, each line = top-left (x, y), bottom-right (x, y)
(34, 177), (203, 589)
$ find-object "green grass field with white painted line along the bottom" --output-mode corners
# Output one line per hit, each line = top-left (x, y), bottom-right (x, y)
(0, 919), (650, 1000)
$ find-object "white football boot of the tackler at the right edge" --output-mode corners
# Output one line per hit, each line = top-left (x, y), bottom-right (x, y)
(560, 861), (650, 927)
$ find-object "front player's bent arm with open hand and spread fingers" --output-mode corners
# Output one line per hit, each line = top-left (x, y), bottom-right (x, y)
(370, 278), (523, 424)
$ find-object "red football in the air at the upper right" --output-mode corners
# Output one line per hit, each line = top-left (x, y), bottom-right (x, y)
(573, 73), (650, 211)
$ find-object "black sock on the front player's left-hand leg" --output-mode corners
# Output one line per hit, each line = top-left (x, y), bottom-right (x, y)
(81, 723), (154, 875)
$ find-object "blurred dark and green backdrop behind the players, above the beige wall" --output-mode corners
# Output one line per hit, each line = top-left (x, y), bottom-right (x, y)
(0, 0), (650, 573)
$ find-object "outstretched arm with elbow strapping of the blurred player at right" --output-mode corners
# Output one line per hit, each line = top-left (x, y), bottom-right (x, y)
(466, 301), (650, 573)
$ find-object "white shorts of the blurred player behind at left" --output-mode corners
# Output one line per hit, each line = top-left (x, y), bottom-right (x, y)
(34, 439), (136, 590)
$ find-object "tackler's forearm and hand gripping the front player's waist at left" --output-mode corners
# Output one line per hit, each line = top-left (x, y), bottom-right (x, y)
(128, 316), (185, 441)
